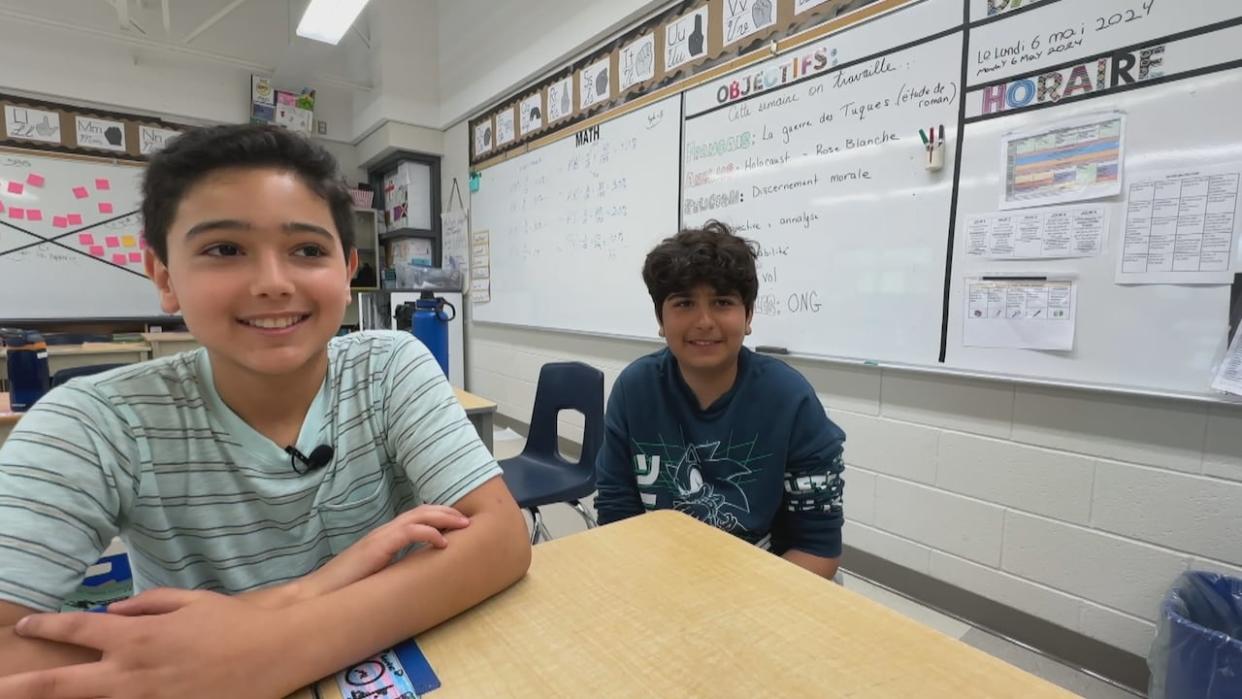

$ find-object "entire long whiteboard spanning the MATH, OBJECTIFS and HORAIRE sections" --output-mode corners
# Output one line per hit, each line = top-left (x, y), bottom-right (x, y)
(464, 0), (1242, 400)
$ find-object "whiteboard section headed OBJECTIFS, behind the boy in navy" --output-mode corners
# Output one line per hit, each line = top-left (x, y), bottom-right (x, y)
(682, 1), (961, 364)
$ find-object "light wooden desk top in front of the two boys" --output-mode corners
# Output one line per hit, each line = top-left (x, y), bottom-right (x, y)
(294, 512), (1073, 699)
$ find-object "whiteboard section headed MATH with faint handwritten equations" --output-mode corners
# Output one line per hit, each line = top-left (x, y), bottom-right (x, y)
(471, 97), (681, 338)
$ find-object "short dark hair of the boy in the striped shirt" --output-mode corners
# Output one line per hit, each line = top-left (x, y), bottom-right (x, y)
(143, 124), (354, 263)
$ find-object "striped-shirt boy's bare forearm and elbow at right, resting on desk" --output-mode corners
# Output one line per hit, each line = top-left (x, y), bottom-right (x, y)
(252, 477), (530, 683)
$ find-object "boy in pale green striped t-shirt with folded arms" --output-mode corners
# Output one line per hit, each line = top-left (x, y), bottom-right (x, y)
(0, 125), (530, 698)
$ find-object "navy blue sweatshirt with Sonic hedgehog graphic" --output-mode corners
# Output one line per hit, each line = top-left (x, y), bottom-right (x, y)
(595, 348), (846, 557)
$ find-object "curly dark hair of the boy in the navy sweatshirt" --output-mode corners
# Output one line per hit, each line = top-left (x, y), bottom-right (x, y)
(642, 220), (759, 322)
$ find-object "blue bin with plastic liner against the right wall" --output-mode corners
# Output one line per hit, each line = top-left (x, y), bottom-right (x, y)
(1148, 571), (1242, 699)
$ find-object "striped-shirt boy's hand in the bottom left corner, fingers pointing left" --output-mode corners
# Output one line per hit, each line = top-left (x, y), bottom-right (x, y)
(0, 589), (298, 699)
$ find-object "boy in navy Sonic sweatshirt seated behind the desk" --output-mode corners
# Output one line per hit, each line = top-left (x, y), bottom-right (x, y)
(595, 221), (845, 577)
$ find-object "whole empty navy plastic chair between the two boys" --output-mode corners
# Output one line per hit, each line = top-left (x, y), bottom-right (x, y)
(501, 361), (604, 544)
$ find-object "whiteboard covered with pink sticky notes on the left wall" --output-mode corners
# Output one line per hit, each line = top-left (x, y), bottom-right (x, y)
(0, 150), (164, 322)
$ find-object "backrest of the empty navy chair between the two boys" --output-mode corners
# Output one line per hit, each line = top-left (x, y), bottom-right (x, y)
(522, 361), (604, 473)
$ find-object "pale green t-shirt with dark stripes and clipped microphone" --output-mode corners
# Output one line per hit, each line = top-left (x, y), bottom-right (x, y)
(0, 331), (501, 610)
